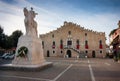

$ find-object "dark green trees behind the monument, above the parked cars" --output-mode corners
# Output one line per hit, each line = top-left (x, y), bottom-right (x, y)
(0, 26), (23, 49)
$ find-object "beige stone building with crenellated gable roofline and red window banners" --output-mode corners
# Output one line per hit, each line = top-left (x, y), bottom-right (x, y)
(40, 22), (106, 58)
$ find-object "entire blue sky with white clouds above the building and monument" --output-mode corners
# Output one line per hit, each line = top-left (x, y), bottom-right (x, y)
(0, 0), (120, 44)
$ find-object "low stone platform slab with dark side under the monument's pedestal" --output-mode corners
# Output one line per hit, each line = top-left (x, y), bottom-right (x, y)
(0, 62), (53, 71)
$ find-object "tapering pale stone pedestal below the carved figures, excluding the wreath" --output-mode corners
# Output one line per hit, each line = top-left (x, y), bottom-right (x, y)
(12, 35), (52, 68)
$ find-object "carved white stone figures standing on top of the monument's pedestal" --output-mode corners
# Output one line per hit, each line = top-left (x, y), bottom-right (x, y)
(23, 7), (37, 37)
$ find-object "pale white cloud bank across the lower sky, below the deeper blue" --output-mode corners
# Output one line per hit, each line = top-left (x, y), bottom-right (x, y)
(0, 0), (120, 43)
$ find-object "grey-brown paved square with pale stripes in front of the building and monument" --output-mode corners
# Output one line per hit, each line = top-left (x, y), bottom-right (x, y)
(0, 57), (120, 81)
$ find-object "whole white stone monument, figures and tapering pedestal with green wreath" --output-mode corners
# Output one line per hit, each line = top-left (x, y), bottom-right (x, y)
(10, 8), (52, 67)
